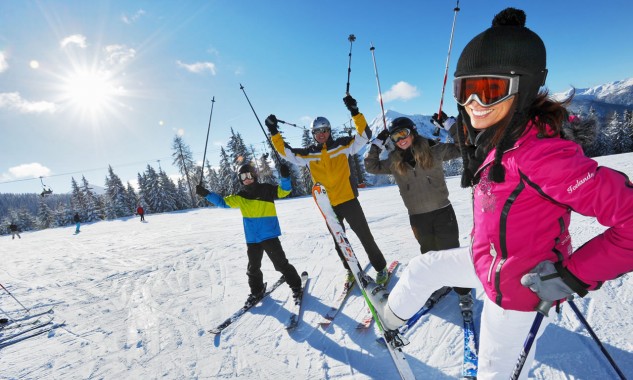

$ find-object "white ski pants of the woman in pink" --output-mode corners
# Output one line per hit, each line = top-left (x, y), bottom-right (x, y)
(389, 247), (550, 380)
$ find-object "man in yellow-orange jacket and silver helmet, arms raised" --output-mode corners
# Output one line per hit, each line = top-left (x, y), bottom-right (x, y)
(266, 95), (388, 283)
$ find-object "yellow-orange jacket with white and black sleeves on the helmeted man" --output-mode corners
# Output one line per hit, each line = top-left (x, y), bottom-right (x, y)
(272, 113), (371, 206)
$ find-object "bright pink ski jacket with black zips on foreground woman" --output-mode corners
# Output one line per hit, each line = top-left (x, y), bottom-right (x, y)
(471, 123), (633, 311)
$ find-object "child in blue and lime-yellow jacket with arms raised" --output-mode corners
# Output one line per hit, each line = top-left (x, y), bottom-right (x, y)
(196, 164), (302, 306)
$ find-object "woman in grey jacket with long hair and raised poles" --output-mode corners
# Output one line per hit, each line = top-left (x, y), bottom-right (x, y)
(365, 115), (472, 314)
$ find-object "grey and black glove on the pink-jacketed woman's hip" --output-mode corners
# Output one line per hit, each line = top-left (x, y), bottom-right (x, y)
(521, 261), (588, 302)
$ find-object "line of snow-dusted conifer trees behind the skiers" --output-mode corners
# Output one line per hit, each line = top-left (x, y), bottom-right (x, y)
(0, 109), (633, 235)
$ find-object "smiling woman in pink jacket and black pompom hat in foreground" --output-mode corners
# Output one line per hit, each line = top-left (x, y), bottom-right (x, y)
(369, 8), (633, 380)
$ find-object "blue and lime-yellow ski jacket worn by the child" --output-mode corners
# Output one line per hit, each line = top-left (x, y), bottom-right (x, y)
(206, 177), (292, 243)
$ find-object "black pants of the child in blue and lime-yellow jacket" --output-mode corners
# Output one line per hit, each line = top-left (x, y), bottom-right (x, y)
(246, 238), (301, 294)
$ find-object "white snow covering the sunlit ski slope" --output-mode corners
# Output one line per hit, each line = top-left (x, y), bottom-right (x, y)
(0, 153), (633, 379)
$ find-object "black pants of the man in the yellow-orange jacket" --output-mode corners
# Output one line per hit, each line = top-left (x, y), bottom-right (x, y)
(332, 198), (387, 271)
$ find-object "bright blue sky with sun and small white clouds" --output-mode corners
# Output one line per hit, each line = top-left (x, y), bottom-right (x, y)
(0, 0), (633, 193)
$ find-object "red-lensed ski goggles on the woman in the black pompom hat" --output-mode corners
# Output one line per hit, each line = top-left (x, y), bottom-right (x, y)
(453, 75), (519, 107)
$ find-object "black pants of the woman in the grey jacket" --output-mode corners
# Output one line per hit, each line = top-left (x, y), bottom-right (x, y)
(409, 205), (470, 294)
